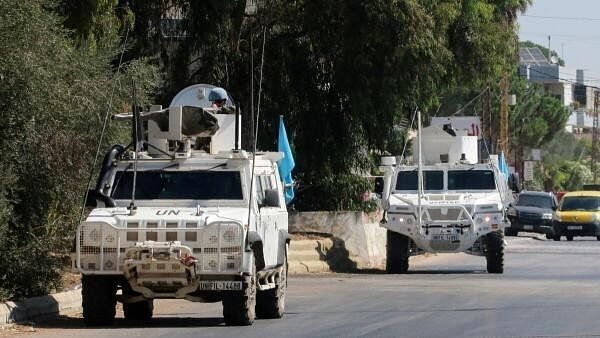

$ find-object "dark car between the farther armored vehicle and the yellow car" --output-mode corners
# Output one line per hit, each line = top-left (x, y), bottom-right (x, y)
(504, 191), (558, 238)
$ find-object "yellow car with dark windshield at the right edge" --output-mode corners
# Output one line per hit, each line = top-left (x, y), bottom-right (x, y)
(553, 191), (600, 241)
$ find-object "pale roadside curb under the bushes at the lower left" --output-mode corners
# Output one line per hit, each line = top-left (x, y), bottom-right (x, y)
(0, 290), (81, 326)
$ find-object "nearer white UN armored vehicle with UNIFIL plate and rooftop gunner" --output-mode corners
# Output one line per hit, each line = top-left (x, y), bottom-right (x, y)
(73, 85), (289, 325)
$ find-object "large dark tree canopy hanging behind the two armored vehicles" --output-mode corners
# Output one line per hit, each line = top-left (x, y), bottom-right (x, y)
(91, 0), (530, 209)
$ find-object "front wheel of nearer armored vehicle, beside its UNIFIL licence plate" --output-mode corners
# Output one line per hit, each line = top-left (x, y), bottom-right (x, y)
(223, 267), (256, 326)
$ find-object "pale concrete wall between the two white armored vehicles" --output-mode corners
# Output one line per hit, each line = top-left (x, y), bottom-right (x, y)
(289, 211), (386, 269)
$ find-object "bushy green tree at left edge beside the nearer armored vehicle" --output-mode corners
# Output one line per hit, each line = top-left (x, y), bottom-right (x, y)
(0, 0), (158, 299)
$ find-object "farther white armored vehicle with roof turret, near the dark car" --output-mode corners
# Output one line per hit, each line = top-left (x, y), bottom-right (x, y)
(380, 119), (512, 273)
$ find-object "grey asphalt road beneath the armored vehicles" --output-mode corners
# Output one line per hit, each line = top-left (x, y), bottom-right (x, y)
(12, 237), (600, 338)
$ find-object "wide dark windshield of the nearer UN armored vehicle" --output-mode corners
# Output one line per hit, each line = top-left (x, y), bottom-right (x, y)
(112, 170), (243, 200)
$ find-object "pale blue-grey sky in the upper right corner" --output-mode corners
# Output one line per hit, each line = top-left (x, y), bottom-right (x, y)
(519, 0), (600, 85)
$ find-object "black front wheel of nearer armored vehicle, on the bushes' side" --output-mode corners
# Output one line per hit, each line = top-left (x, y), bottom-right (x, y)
(81, 275), (117, 326)
